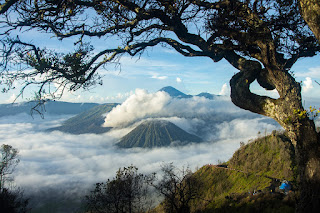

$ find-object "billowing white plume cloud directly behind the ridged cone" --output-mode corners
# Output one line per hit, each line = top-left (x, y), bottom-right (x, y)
(104, 89), (248, 127)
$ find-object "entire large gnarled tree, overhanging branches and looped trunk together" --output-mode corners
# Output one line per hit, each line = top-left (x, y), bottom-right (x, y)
(0, 0), (320, 212)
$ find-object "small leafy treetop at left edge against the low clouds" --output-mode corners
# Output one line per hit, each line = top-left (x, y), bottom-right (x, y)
(0, 144), (20, 191)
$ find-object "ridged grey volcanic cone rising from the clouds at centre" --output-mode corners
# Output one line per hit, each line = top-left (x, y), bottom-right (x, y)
(116, 120), (202, 148)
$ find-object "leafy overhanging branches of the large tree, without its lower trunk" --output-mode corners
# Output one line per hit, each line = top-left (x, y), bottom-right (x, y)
(0, 0), (319, 101)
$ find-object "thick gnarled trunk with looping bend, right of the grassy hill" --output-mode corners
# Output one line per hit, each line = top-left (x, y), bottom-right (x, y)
(230, 61), (320, 212)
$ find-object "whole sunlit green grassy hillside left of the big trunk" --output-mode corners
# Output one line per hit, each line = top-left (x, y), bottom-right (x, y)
(192, 132), (295, 212)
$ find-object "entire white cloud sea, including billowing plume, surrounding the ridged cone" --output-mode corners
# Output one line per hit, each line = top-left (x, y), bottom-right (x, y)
(0, 90), (281, 212)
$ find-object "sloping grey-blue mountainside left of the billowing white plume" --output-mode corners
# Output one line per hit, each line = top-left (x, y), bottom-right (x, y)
(48, 104), (118, 134)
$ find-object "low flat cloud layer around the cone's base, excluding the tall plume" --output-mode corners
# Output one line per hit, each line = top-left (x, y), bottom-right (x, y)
(0, 115), (278, 198)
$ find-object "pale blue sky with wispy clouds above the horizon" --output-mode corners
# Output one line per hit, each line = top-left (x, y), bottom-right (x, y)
(0, 28), (320, 103)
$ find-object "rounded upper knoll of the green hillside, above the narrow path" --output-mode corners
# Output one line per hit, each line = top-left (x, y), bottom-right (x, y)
(228, 134), (294, 181)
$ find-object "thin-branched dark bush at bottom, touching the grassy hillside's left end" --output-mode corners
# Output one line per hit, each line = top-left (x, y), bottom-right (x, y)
(151, 164), (201, 213)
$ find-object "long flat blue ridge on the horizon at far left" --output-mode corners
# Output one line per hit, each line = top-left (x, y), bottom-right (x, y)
(0, 101), (98, 117)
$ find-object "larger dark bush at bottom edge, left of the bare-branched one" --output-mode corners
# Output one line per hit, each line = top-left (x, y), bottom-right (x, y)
(86, 166), (149, 213)
